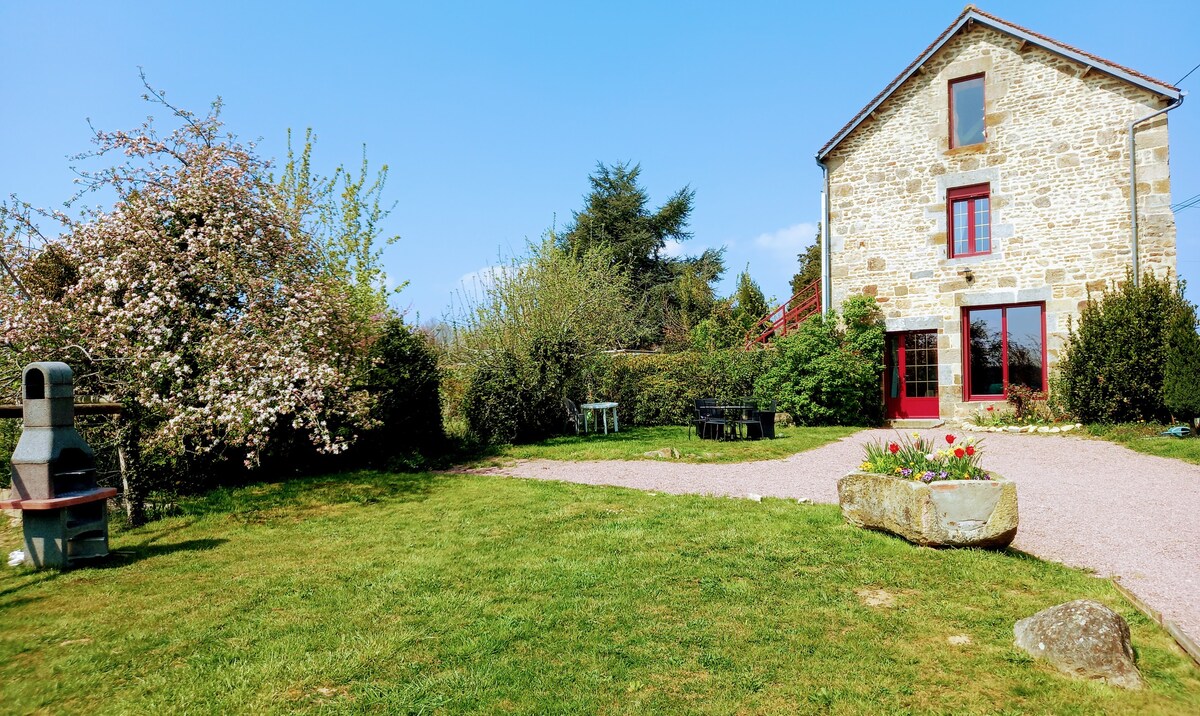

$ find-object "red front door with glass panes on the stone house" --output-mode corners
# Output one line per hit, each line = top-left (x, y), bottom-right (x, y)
(883, 331), (938, 419)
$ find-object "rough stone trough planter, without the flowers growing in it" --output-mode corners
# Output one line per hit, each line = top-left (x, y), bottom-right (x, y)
(838, 473), (1016, 548)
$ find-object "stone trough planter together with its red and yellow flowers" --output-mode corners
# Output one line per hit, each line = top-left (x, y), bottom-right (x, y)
(838, 433), (1016, 548)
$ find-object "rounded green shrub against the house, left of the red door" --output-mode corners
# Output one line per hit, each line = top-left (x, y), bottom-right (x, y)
(757, 296), (883, 426)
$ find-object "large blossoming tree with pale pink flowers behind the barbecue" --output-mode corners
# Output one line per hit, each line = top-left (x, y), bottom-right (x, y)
(0, 85), (367, 520)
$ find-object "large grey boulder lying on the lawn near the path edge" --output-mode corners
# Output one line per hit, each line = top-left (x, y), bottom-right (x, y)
(1013, 600), (1142, 688)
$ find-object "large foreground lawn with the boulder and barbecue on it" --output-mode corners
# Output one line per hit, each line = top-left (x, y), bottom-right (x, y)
(0, 473), (1200, 715)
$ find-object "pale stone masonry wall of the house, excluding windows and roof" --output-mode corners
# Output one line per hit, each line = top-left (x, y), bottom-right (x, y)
(827, 25), (1175, 417)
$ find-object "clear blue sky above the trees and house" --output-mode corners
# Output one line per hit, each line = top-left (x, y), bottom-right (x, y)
(0, 0), (1200, 321)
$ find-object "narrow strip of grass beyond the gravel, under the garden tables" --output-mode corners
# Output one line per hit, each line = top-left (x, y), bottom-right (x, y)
(468, 427), (862, 463)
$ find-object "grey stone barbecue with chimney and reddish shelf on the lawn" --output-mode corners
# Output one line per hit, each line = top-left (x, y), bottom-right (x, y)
(0, 362), (116, 567)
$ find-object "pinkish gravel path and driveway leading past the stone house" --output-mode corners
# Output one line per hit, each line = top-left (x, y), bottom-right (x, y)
(482, 429), (1200, 642)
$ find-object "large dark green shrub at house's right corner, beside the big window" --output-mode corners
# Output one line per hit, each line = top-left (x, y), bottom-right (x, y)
(1058, 275), (1187, 422)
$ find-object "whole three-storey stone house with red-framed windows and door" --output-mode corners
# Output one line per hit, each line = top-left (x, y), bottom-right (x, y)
(816, 6), (1183, 419)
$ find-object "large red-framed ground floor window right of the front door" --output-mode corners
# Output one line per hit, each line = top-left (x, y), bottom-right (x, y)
(962, 303), (1046, 401)
